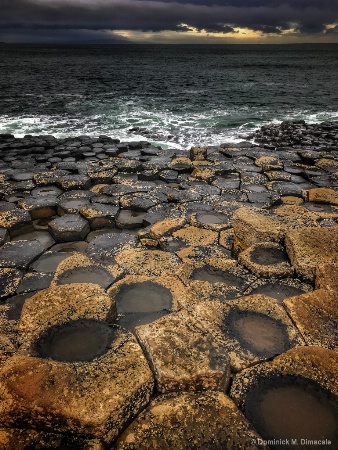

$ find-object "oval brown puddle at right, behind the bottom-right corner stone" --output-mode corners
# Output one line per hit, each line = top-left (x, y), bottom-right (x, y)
(228, 310), (289, 358)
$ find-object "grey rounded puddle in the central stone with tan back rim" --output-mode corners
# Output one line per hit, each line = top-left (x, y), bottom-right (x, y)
(115, 281), (172, 314)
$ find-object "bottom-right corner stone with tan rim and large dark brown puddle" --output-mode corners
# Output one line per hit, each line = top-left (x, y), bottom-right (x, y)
(230, 347), (338, 449)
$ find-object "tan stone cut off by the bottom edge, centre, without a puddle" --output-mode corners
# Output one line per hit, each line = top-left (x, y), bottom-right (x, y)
(112, 392), (267, 450)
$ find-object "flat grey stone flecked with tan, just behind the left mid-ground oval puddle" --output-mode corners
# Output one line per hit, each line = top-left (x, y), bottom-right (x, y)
(87, 233), (138, 264)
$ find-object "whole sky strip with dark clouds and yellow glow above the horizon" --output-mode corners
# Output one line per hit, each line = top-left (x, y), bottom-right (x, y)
(0, 0), (338, 44)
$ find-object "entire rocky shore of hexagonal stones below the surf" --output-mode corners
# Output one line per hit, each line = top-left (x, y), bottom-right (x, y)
(0, 122), (338, 450)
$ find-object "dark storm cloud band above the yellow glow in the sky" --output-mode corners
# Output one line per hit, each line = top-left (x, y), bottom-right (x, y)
(0, 0), (338, 34)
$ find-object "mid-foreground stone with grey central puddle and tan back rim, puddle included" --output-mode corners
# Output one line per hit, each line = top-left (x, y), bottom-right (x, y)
(108, 275), (192, 331)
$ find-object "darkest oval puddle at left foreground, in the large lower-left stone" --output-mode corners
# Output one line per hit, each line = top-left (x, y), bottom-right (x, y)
(36, 319), (116, 362)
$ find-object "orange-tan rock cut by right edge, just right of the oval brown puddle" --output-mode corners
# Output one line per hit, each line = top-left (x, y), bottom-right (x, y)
(283, 289), (338, 349)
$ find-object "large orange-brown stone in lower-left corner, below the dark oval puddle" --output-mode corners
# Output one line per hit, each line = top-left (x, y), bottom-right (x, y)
(0, 323), (153, 445)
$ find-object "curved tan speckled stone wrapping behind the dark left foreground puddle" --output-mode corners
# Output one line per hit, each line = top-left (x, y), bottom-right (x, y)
(19, 283), (116, 339)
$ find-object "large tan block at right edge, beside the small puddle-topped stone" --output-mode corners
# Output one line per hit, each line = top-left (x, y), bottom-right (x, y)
(285, 227), (338, 282)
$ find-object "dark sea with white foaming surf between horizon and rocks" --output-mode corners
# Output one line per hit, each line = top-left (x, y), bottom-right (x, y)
(0, 44), (338, 148)
